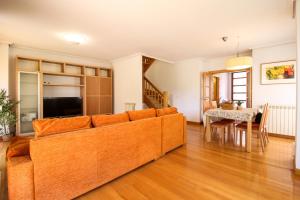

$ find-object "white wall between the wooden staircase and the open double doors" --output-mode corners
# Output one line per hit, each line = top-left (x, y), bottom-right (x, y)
(146, 58), (203, 122)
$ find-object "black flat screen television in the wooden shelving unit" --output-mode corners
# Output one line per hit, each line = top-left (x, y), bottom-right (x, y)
(43, 97), (83, 118)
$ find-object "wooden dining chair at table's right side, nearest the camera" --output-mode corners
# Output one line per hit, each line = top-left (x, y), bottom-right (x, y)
(234, 104), (268, 152)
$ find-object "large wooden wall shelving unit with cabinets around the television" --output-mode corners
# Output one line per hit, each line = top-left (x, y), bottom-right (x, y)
(16, 56), (113, 134)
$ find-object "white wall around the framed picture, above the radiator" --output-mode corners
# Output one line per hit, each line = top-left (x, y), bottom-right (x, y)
(252, 43), (297, 107)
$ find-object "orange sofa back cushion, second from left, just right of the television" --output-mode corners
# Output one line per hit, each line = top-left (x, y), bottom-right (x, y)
(92, 113), (129, 127)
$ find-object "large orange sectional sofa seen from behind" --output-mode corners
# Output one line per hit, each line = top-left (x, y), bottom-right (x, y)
(7, 108), (186, 200)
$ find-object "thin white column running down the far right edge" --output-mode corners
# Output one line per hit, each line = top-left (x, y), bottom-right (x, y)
(295, 0), (300, 170)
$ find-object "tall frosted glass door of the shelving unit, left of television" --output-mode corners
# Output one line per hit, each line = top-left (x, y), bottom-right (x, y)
(18, 72), (40, 134)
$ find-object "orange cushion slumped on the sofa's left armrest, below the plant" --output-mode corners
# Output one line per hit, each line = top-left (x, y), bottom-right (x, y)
(6, 137), (31, 158)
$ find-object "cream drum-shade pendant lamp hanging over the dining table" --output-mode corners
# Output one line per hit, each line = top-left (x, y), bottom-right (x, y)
(225, 38), (253, 70)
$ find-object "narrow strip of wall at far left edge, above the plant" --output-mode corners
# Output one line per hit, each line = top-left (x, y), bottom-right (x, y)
(0, 43), (9, 90)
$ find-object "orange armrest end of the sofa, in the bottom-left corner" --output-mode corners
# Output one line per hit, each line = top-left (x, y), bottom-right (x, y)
(7, 156), (34, 200)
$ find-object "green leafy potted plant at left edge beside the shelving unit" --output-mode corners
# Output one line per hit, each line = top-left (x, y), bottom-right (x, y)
(0, 89), (18, 141)
